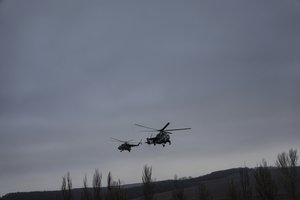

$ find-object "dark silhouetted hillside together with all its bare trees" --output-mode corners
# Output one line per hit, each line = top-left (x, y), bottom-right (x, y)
(0, 149), (300, 200)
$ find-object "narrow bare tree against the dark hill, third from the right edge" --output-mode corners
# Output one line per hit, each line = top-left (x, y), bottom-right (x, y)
(240, 167), (252, 200)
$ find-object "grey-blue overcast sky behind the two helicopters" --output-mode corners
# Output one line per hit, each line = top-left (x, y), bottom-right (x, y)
(0, 0), (300, 195)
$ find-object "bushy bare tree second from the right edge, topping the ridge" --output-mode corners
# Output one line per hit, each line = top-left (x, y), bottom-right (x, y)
(254, 159), (277, 200)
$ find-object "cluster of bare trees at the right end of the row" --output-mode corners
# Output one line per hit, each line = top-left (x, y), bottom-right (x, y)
(228, 149), (300, 200)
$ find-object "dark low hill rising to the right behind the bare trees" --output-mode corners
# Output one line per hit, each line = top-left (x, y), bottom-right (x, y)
(0, 167), (300, 200)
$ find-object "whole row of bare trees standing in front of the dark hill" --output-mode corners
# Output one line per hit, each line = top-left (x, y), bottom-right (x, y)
(61, 149), (300, 200)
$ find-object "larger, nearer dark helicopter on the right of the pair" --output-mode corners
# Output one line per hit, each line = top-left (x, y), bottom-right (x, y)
(135, 122), (191, 147)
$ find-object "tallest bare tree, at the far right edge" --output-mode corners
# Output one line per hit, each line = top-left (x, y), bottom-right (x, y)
(276, 149), (298, 200)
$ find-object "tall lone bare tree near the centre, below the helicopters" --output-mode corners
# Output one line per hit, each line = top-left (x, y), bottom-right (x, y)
(142, 165), (154, 200)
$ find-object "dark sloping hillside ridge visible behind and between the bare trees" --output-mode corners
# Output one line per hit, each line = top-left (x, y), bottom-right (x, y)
(0, 167), (300, 200)
